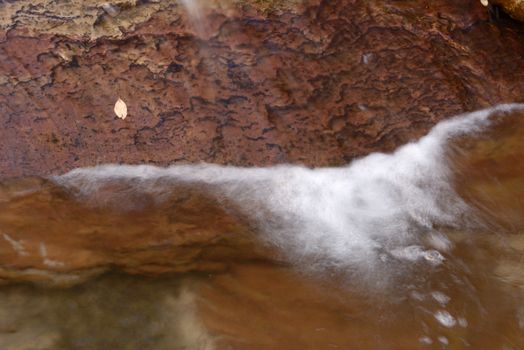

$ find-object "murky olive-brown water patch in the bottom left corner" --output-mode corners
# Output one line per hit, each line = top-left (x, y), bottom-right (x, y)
(0, 274), (214, 350)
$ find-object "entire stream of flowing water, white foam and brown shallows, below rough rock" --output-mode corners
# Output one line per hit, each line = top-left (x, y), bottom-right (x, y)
(0, 105), (524, 350)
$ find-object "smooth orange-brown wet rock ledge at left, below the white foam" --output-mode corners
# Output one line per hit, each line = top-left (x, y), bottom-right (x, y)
(0, 178), (279, 286)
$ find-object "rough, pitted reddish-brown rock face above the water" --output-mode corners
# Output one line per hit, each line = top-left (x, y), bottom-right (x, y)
(0, 0), (524, 177)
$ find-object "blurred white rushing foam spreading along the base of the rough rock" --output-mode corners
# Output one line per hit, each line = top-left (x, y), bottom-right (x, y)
(53, 104), (524, 273)
